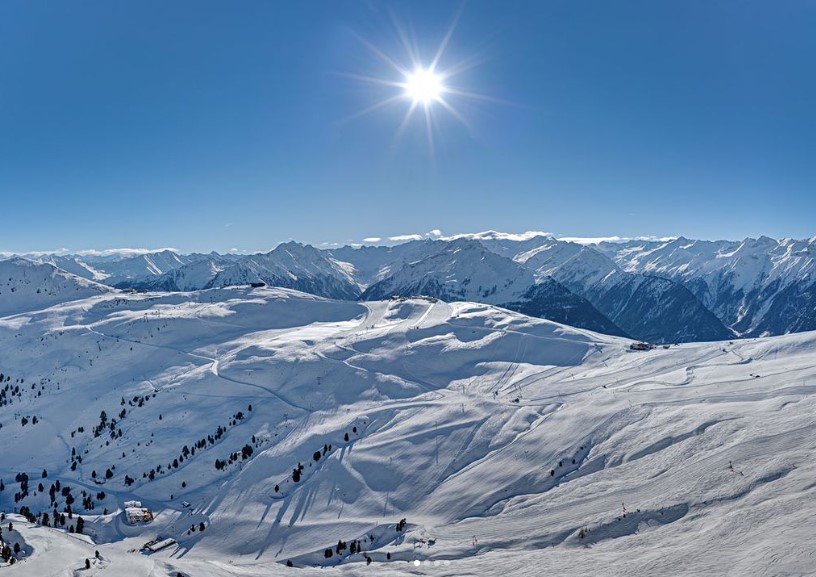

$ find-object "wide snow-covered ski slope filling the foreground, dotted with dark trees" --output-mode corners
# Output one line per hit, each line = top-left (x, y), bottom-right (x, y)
(0, 288), (816, 577)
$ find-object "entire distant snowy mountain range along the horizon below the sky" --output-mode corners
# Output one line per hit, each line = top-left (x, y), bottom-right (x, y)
(7, 232), (816, 343)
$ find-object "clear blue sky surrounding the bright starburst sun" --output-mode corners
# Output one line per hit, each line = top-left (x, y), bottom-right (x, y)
(0, 0), (816, 251)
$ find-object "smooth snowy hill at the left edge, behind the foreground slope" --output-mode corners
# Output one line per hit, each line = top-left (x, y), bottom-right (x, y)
(0, 258), (113, 316)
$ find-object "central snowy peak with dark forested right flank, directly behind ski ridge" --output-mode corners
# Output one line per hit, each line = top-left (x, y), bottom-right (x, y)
(361, 238), (625, 335)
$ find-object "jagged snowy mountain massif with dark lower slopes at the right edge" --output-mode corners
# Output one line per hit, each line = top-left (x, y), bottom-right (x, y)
(599, 236), (816, 336)
